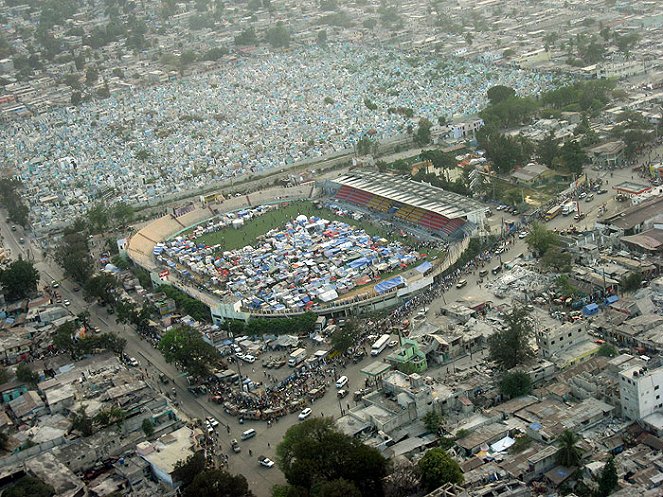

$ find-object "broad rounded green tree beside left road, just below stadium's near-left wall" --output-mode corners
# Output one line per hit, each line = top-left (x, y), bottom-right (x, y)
(158, 326), (219, 378)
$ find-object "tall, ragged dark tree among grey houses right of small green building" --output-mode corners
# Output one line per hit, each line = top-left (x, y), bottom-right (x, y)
(488, 307), (533, 370)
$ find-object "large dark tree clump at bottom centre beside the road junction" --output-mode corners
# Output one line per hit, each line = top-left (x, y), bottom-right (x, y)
(276, 417), (387, 497)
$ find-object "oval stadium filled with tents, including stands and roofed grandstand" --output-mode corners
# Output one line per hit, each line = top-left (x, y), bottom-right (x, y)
(126, 172), (485, 323)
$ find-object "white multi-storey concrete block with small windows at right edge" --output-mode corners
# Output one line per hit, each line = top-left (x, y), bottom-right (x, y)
(619, 366), (663, 420)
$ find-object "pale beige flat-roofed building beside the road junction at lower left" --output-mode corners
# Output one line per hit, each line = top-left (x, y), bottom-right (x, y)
(136, 426), (198, 487)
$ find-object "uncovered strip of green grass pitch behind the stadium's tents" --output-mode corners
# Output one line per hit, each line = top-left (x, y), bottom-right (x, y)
(196, 200), (414, 250)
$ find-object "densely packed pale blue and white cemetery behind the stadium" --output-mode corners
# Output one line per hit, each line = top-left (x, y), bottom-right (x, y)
(0, 45), (553, 226)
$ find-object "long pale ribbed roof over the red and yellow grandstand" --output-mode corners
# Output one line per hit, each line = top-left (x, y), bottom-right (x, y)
(334, 172), (486, 219)
